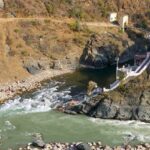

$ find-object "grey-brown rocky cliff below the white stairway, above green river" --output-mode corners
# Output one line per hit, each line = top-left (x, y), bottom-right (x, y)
(67, 68), (150, 122)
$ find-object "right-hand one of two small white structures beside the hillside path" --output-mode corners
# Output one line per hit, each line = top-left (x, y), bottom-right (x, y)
(119, 15), (129, 31)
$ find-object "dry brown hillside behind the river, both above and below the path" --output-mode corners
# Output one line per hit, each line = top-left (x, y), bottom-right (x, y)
(0, 0), (150, 83)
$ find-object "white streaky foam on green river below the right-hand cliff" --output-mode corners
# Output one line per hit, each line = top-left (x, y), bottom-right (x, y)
(89, 118), (150, 143)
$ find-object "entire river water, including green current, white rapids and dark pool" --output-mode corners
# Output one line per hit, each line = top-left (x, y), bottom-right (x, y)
(0, 67), (150, 150)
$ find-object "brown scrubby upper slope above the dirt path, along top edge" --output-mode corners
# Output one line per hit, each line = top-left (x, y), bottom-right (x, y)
(1, 0), (150, 20)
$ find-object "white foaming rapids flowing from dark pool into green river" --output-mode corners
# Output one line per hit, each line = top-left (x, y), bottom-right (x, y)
(0, 82), (72, 114)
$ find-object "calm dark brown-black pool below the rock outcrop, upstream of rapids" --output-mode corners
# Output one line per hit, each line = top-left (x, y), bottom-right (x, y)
(54, 66), (116, 95)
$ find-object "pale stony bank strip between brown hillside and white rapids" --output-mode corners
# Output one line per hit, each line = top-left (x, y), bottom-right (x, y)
(0, 69), (73, 103)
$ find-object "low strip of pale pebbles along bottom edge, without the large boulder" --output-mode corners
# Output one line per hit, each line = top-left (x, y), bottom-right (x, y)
(19, 142), (150, 150)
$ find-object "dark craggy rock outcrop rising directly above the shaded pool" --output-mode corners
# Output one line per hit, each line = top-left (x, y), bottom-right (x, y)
(80, 30), (150, 68)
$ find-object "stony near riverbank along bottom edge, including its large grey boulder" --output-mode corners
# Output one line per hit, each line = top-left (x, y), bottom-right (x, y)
(16, 133), (150, 150)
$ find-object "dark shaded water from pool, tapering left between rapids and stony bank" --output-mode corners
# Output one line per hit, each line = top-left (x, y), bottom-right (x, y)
(10, 66), (116, 101)
